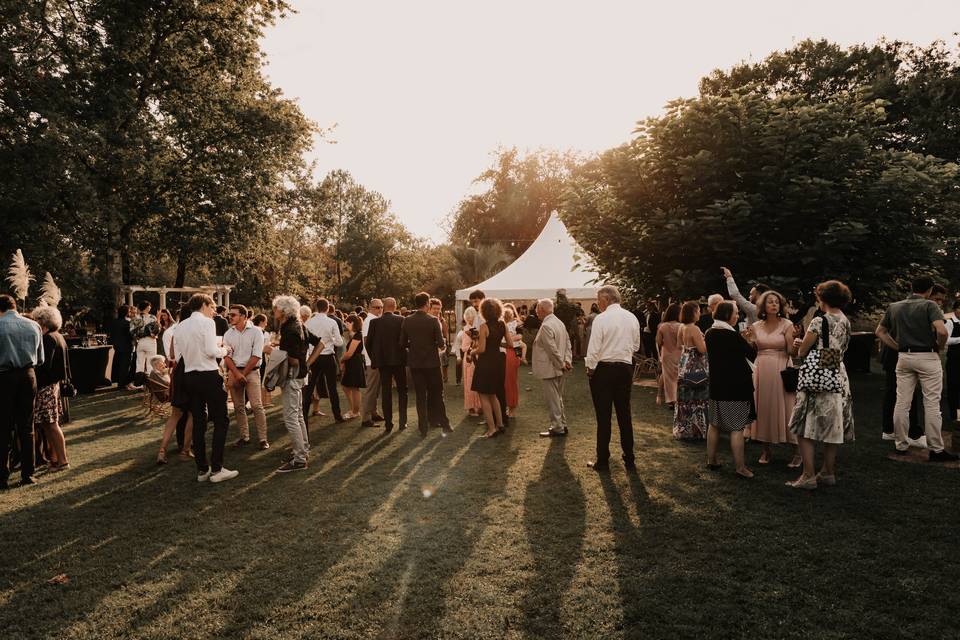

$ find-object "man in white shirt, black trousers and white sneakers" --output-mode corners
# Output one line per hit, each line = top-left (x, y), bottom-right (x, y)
(176, 293), (239, 482)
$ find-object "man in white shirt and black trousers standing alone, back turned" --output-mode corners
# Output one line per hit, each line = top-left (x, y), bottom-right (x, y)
(585, 285), (640, 471)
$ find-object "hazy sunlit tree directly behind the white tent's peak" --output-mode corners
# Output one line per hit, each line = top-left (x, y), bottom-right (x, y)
(450, 147), (578, 257)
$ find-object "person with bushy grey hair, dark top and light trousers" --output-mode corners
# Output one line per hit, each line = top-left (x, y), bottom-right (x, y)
(273, 296), (310, 473)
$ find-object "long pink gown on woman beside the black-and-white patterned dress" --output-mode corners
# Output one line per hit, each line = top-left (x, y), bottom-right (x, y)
(751, 319), (797, 444)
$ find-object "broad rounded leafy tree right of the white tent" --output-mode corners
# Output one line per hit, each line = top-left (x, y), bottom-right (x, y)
(563, 87), (960, 307)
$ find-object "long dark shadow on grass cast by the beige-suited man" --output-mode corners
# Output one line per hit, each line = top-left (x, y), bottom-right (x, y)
(522, 438), (587, 637)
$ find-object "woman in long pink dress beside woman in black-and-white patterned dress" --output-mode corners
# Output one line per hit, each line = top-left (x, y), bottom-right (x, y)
(751, 291), (802, 467)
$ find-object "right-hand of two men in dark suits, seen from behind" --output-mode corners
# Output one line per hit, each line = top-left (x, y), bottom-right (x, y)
(400, 291), (451, 438)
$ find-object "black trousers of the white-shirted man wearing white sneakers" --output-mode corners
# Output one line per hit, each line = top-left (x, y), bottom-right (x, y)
(183, 371), (230, 473)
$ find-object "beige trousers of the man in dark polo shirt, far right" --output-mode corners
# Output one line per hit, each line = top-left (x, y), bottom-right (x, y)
(893, 353), (943, 451)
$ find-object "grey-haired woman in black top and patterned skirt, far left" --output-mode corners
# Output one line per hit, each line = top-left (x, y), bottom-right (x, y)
(31, 306), (70, 472)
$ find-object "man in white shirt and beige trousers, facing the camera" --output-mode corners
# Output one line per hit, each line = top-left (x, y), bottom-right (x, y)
(223, 304), (270, 451)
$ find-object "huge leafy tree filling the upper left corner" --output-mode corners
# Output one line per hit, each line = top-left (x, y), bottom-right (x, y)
(0, 0), (315, 318)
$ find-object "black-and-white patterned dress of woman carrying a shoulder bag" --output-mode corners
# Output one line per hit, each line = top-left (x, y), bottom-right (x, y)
(790, 313), (854, 444)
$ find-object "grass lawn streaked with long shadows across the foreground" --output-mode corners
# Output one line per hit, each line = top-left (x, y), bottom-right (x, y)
(0, 369), (960, 639)
